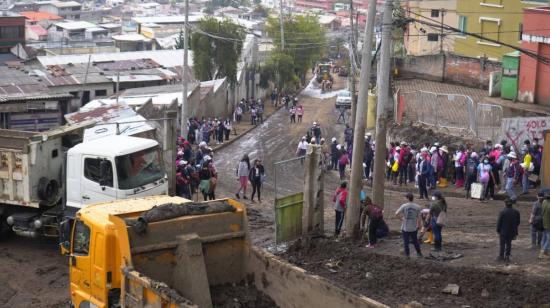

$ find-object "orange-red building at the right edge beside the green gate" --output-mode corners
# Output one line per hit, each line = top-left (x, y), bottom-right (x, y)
(520, 6), (550, 106)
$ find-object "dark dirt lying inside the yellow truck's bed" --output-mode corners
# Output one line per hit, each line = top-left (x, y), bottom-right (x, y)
(210, 283), (277, 308)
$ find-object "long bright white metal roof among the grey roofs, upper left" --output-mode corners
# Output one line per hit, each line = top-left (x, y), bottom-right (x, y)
(37, 49), (193, 67)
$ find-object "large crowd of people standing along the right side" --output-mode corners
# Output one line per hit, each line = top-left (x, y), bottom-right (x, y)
(386, 139), (543, 202)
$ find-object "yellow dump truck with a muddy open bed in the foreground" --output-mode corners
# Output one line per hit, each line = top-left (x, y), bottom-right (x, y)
(62, 196), (385, 308)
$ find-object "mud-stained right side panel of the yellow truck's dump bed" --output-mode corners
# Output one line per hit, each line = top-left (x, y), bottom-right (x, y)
(247, 247), (387, 308)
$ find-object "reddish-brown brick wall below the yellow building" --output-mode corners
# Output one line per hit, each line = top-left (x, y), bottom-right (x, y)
(397, 54), (501, 89)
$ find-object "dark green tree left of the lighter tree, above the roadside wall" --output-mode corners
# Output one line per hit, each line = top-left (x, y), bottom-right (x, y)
(191, 17), (245, 86)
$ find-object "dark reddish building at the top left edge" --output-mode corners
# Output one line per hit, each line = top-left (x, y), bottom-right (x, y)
(0, 11), (25, 53)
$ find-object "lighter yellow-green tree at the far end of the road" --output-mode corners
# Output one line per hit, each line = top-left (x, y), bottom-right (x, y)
(267, 15), (326, 82)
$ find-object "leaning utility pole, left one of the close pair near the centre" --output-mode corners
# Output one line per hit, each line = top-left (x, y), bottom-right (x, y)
(345, 0), (382, 238)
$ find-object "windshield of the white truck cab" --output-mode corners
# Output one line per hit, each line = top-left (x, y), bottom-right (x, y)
(115, 147), (164, 189)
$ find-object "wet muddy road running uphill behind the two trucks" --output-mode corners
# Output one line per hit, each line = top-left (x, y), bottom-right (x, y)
(214, 80), (352, 247)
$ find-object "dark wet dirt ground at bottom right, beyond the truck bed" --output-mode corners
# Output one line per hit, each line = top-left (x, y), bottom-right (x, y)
(281, 239), (550, 307)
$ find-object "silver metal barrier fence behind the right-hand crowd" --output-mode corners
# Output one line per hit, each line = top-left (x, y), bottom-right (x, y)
(396, 91), (503, 140)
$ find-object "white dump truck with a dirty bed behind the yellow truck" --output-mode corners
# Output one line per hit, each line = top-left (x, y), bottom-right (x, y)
(0, 126), (168, 237)
